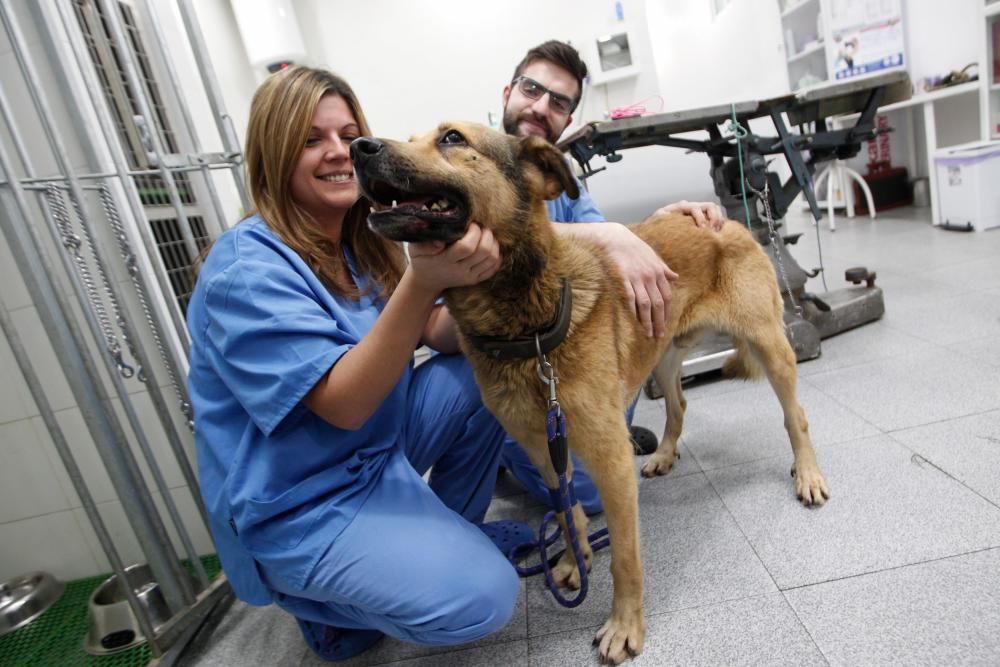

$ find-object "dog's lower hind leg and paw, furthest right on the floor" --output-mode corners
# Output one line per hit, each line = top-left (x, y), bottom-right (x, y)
(748, 322), (830, 505)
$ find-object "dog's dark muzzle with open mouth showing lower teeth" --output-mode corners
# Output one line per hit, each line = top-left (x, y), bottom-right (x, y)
(361, 177), (468, 243)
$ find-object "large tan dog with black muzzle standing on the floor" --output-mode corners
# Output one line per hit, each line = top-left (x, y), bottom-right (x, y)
(351, 123), (829, 664)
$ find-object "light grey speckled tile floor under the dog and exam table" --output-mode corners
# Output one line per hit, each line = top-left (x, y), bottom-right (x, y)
(184, 209), (1000, 667)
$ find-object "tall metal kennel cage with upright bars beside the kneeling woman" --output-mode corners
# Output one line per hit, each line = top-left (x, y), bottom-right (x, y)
(0, 0), (248, 659)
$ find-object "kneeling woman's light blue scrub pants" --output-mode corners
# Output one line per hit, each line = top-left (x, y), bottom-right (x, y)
(264, 355), (520, 645)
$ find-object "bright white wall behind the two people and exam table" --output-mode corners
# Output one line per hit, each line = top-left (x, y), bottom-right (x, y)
(276, 0), (786, 220)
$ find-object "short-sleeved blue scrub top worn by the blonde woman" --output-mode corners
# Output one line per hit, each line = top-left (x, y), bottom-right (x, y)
(187, 216), (412, 604)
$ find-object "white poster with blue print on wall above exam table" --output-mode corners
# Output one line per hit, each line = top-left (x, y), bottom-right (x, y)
(827, 0), (905, 79)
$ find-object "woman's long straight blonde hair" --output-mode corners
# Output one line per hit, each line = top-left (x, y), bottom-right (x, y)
(244, 66), (404, 298)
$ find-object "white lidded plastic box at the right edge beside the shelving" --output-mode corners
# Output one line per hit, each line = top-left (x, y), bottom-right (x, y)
(934, 141), (1000, 232)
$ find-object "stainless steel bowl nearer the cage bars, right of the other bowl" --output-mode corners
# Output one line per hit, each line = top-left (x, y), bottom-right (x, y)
(83, 564), (199, 655)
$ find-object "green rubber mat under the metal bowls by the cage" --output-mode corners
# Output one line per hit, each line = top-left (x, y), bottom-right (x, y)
(0, 554), (222, 667)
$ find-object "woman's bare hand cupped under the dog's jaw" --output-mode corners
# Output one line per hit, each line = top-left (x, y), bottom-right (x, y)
(409, 223), (500, 294)
